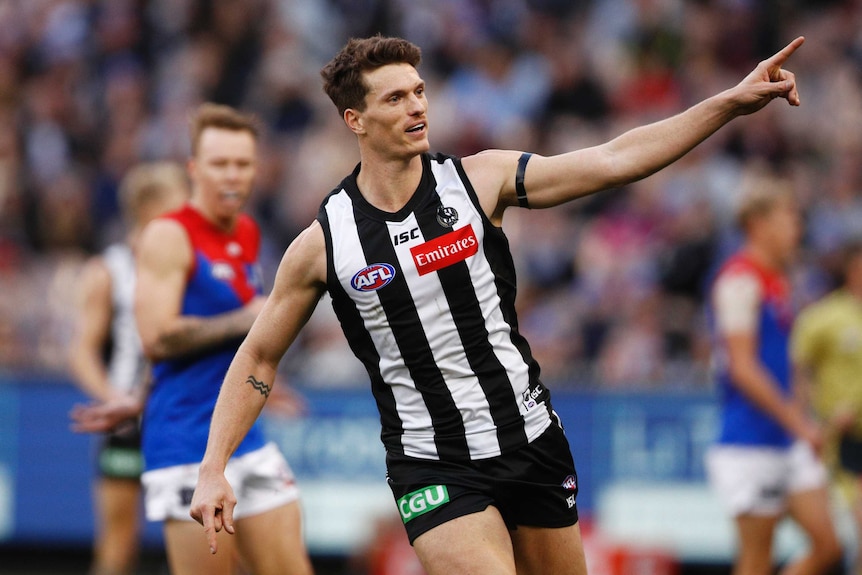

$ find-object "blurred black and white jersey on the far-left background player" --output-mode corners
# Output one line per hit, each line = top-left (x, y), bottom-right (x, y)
(102, 243), (148, 392)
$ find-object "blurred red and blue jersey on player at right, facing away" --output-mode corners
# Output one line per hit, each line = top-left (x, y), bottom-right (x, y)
(713, 254), (793, 448)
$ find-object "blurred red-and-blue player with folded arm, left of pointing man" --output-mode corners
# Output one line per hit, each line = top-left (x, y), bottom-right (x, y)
(77, 103), (311, 575)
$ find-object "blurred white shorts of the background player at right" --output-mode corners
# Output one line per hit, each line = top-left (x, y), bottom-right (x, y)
(706, 441), (827, 517)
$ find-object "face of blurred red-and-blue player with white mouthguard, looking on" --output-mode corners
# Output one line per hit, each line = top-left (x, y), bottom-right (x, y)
(189, 128), (257, 219)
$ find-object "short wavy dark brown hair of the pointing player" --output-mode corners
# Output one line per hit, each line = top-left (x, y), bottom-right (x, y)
(320, 35), (422, 115)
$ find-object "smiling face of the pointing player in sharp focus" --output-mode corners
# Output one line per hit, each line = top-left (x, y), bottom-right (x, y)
(357, 64), (430, 158)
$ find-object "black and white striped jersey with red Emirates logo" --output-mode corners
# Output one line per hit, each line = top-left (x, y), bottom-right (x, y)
(318, 154), (556, 460)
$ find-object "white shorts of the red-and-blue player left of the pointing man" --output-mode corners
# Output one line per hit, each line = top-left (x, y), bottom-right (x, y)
(141, 443), (299, 521)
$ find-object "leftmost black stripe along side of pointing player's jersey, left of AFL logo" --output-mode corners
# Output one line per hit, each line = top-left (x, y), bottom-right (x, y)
(317, 198), (404, 454)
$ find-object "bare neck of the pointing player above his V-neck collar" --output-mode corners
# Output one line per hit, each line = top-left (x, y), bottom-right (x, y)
(356, 150), (422, 212)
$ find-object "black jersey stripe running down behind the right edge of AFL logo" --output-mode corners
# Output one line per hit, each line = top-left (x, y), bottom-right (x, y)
(354, 200), (470, 460)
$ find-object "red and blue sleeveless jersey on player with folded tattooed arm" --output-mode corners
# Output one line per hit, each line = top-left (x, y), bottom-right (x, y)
(142, 205), (265, 470)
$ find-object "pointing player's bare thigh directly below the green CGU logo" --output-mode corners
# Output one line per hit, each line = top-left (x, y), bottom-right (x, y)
(413, 507), (516, 575)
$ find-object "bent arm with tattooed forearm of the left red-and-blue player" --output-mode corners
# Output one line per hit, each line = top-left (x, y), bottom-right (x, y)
(135, 219), (265, 361)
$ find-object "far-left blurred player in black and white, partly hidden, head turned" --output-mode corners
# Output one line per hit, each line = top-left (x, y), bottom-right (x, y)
(69, 162), (189, 575)
